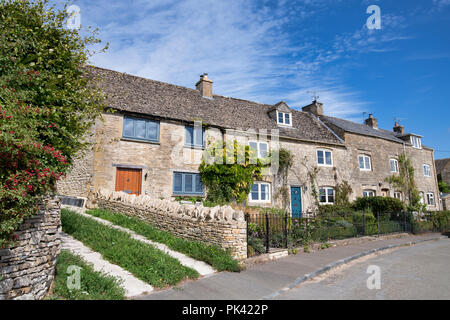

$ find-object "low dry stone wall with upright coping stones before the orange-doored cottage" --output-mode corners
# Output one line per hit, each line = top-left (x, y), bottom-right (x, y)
(96, 189), (247, 260)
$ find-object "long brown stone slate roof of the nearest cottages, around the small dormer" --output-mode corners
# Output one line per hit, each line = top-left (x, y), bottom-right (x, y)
(87, 67), (343, 145)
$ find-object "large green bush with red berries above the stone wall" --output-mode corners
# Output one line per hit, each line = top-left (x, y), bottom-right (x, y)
(0, 0), (104, 247)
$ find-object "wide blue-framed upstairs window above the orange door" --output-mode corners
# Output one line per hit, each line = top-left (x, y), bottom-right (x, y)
(122, 117), (159, 142)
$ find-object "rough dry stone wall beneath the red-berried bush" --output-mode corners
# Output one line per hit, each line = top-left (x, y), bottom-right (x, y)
(0, 198), (61, 300)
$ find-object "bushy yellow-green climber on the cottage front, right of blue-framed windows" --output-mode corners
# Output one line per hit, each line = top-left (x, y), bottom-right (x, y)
(199, 141), (267, 204)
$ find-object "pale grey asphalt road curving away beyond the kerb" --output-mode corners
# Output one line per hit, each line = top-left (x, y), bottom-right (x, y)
(275, 239), (450, 300)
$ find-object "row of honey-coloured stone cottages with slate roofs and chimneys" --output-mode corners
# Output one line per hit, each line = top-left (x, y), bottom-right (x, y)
(58, 67), (439, 216)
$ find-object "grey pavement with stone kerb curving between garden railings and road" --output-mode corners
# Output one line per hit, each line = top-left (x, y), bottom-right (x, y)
(135, 234), (449, 300)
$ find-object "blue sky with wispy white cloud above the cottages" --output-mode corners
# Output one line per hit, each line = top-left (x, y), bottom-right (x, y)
(62, 0), (450, 158)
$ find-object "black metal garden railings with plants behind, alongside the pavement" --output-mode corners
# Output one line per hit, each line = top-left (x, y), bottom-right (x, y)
(245, 212), (420, 256)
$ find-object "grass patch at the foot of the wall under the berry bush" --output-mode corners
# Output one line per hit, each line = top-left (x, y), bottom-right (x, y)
(47, 250), (125, 300)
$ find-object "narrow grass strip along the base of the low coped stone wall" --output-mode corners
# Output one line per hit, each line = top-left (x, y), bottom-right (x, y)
(86, 209), (241, 272)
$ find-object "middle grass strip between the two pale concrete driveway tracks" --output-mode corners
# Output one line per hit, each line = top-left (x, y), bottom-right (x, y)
(61, 209), (199, 288)
